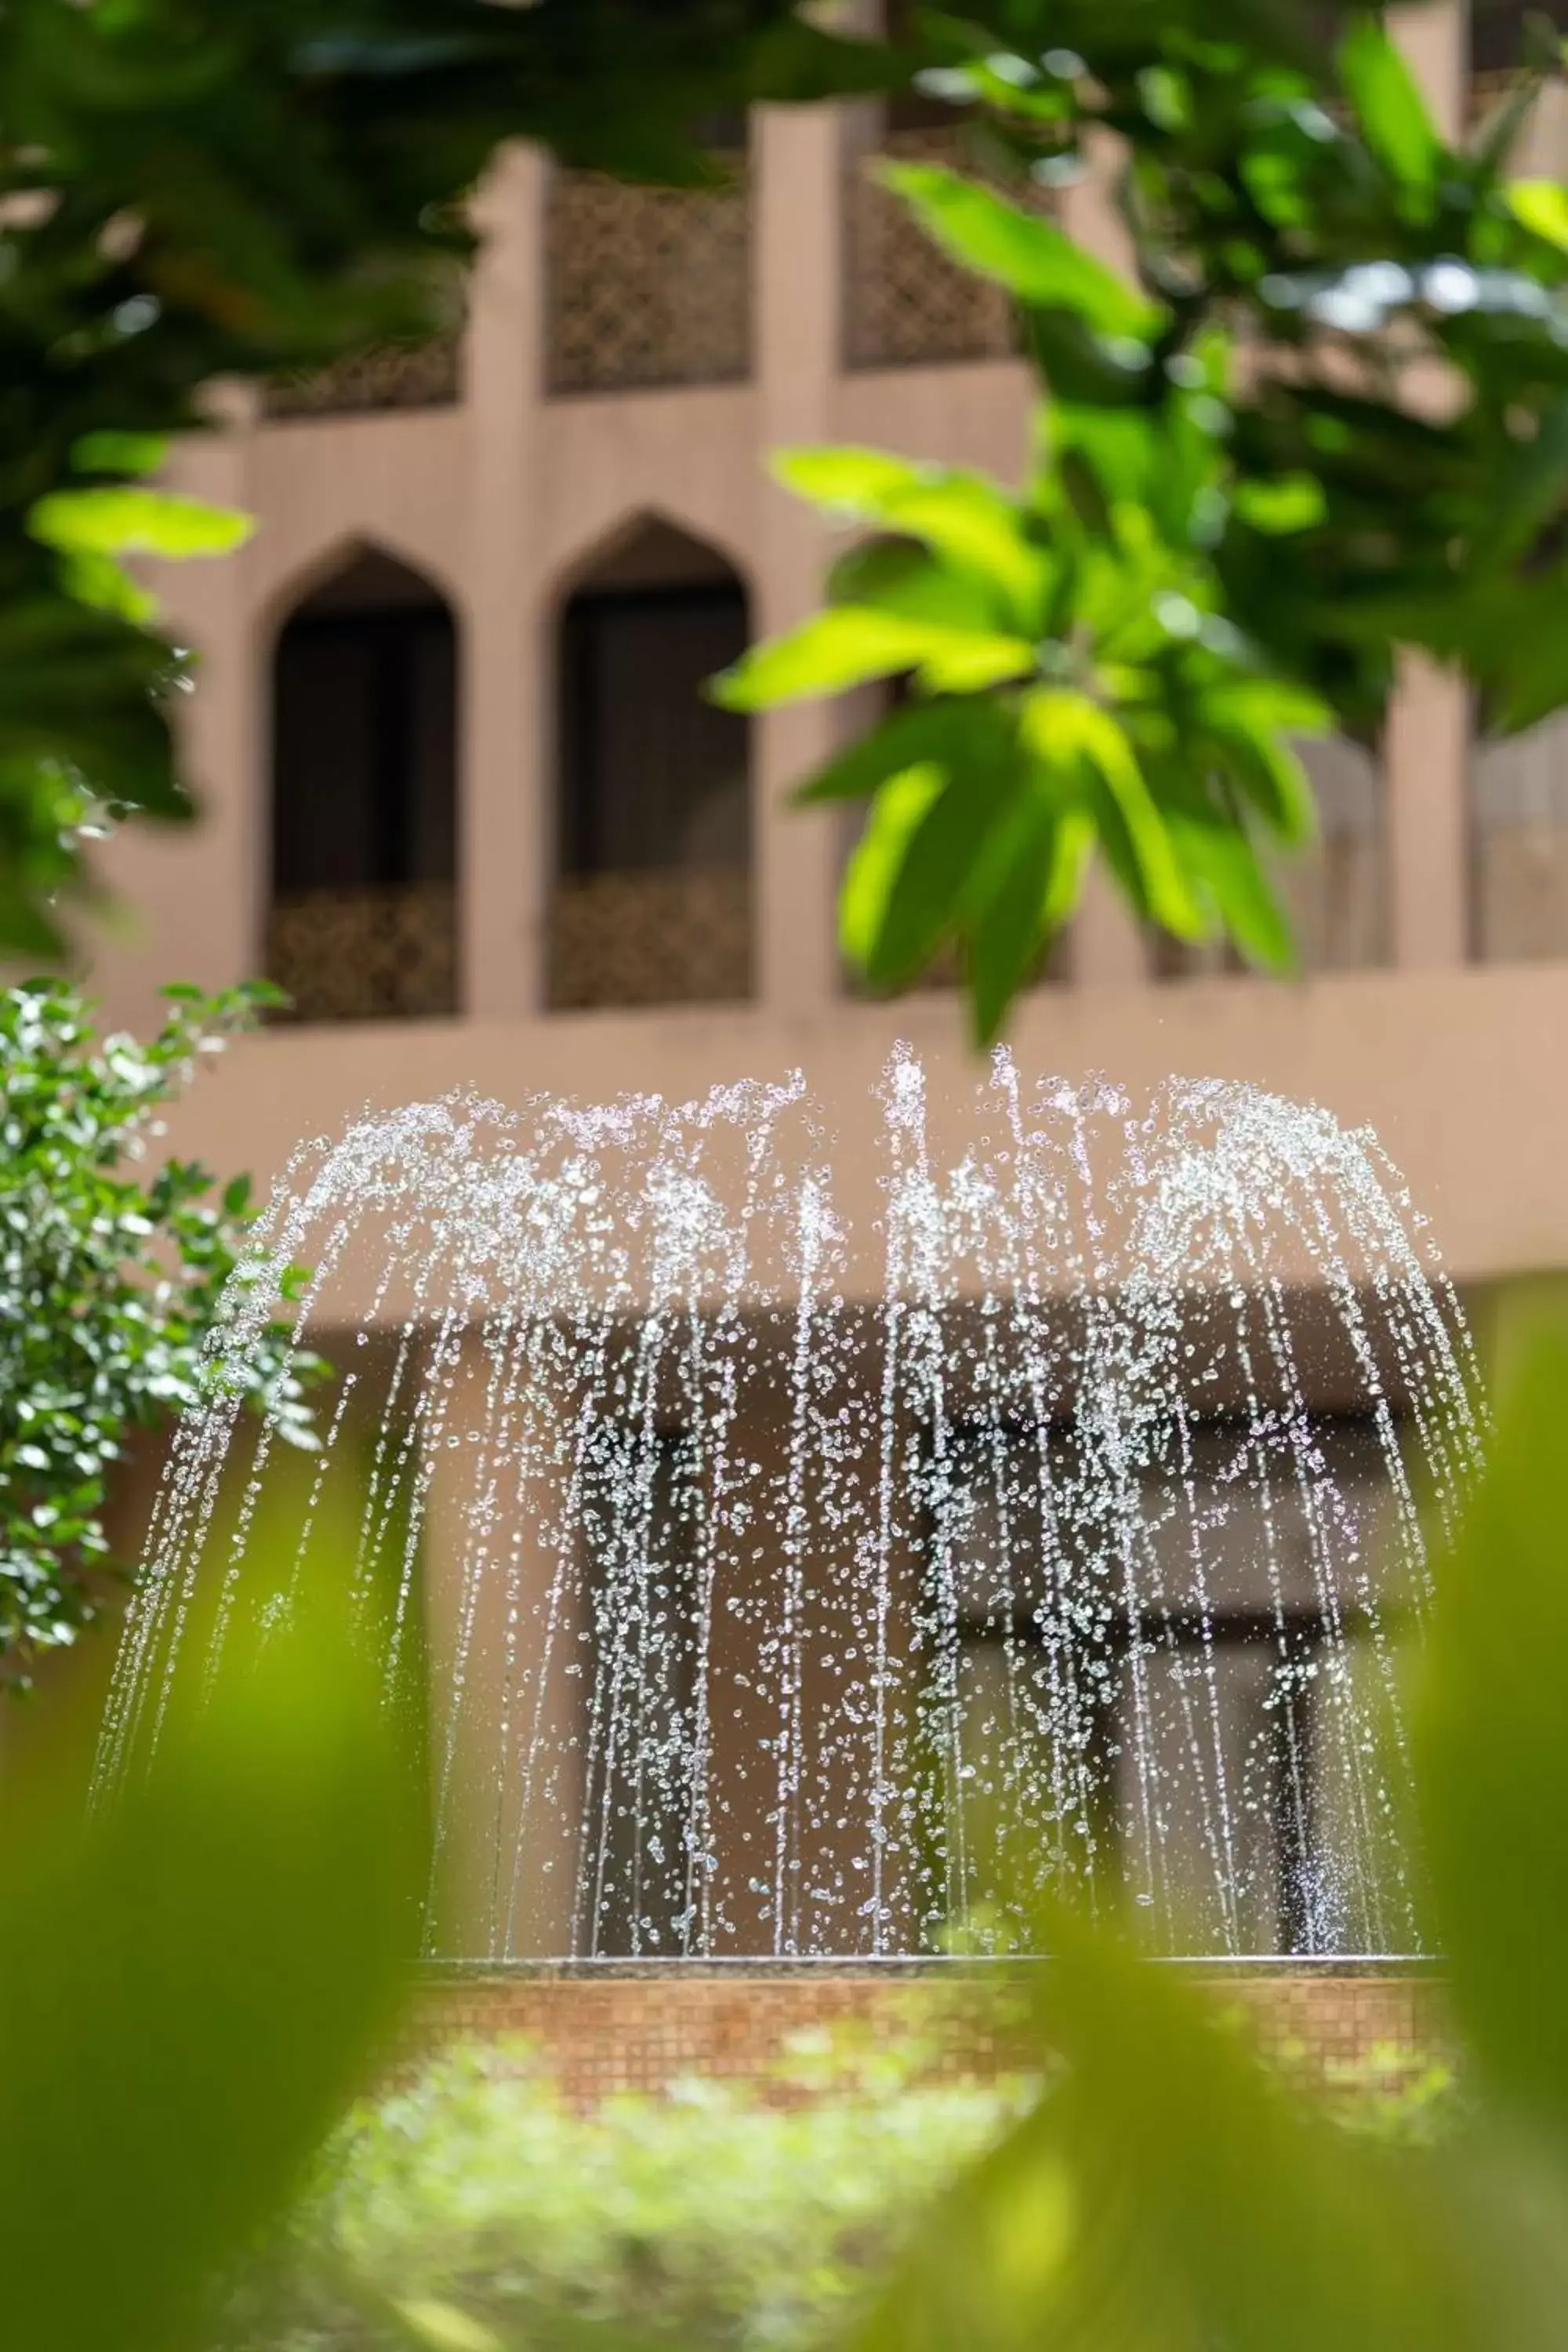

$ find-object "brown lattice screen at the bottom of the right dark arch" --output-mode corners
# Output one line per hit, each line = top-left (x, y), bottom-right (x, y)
(550, 868), (753, 1011)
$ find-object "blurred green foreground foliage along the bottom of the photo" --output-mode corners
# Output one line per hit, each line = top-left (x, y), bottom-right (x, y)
(31, 1331), (1568, 2352)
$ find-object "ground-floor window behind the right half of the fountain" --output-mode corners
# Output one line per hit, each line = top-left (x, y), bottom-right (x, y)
(926, 1416), (1387, 1952)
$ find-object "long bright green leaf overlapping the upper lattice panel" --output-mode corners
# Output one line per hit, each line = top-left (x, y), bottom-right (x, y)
(877, 162), (1163, 341)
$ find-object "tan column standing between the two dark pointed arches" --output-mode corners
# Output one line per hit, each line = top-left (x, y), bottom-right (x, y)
(459, 148), (550, 1021)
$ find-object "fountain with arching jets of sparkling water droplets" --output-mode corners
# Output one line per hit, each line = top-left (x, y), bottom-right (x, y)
(101, 1049), (1479, 1962)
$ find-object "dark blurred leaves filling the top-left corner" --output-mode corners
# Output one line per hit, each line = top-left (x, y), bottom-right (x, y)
(0, 0), (886, 955)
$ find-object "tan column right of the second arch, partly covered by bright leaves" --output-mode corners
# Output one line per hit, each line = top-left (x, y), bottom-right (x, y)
(753, 108), (846, 1014)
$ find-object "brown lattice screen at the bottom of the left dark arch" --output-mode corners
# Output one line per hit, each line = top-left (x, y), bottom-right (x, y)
(266, 882), (459, 1021)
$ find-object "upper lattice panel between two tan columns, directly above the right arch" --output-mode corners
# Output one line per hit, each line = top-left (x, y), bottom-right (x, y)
(546, 158), (753, 395)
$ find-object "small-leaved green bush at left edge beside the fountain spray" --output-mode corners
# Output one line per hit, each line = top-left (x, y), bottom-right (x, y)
(0, 981), (325, 1682)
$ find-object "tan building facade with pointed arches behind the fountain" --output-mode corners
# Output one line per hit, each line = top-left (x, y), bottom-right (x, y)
(73, 7), (1568, 1952)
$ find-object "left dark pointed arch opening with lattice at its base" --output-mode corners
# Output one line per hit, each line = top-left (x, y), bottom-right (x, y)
(268, 548), (459, 1021)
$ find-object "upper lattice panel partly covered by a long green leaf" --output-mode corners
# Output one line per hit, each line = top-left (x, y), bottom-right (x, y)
(844, 122), (1048, 367)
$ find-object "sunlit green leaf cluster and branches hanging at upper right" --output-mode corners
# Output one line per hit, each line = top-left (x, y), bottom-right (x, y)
(717, 0), (1568, 1040)
